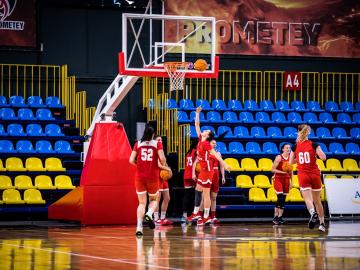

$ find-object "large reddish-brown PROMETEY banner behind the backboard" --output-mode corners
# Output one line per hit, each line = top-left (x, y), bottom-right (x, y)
(165, 0), (360, 58)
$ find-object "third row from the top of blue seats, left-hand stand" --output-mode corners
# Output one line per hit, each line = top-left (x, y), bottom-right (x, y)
(0, 124), (65, 137)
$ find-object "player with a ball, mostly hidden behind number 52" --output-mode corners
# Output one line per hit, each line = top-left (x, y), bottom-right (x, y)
(154, 136), (173, 225)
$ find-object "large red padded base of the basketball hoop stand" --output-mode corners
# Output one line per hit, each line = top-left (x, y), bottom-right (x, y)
(49, 123), (138, 225)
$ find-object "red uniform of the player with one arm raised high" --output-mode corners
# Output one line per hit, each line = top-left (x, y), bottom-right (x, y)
(197, 136), (214, 188)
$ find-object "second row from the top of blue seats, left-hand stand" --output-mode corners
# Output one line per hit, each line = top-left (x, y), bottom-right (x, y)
(0, 108), (55, 121)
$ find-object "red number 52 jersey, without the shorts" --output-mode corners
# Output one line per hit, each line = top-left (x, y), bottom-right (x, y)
(133, 140), (163, 180)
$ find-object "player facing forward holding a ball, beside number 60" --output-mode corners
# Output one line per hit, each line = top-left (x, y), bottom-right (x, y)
(271, 143), (292, 225)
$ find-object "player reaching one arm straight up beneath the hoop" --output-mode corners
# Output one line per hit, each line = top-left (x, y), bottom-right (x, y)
(187, 107), (230, 226)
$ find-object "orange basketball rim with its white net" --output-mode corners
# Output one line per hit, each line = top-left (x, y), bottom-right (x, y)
(164, 62), (190, 91)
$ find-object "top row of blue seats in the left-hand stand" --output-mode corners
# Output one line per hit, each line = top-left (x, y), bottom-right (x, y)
(0, 96), (64, 108)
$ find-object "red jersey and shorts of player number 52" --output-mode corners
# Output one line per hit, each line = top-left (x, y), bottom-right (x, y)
(133, 140), (163, 195)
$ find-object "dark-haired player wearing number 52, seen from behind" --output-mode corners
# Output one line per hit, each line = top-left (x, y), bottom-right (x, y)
(129, 125), (166, 236)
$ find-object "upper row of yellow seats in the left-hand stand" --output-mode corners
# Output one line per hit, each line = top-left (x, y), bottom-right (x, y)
(0, 157), (66, 172)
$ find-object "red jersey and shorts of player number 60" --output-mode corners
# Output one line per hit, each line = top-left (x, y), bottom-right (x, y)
(293, 140), (322, 191)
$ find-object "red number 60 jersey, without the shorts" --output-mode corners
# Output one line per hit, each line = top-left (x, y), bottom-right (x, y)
(293, 140), (320, 174)
